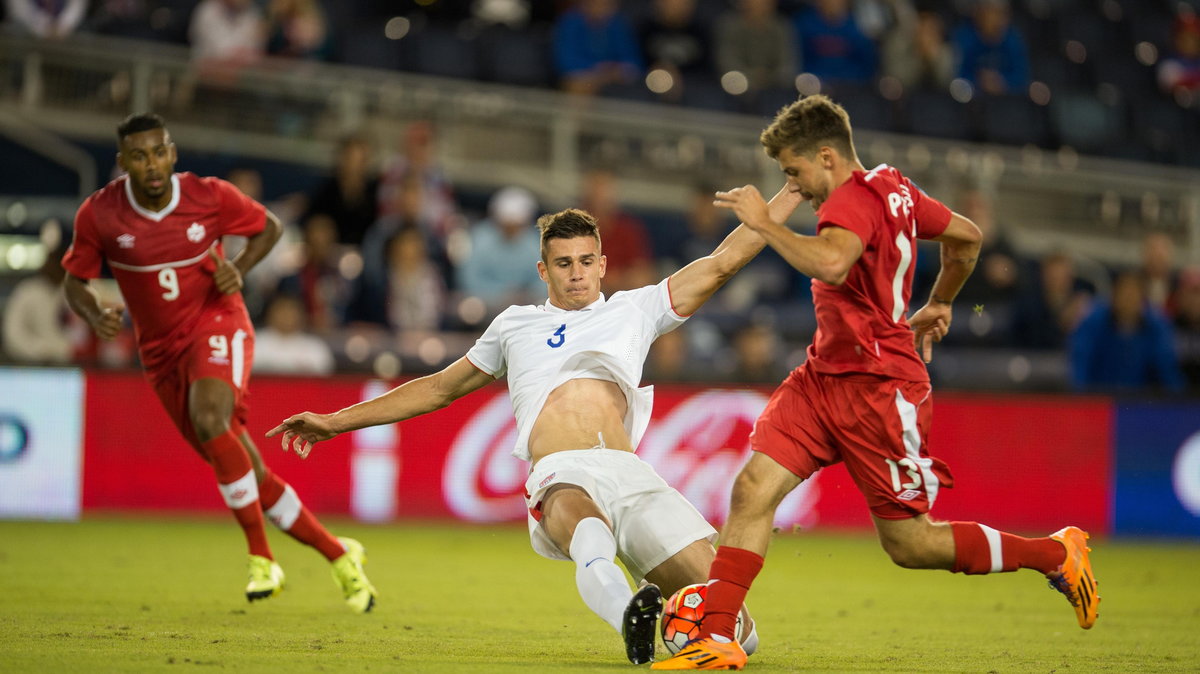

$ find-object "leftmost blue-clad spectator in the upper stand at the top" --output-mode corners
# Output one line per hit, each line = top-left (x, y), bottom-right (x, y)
(553, 0), (643, 95)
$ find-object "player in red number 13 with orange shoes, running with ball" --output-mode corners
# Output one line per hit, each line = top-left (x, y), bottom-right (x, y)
(653, 96), (1099, 669)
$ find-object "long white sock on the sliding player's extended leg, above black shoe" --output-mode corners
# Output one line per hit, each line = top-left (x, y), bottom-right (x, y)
(570, 517), (634, 633)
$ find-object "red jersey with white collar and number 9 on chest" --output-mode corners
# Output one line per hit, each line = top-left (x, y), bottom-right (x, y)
(62, 173), (266, 369)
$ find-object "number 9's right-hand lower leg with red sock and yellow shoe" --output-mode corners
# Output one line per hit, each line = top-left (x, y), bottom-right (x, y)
(234, 422), (378, 613)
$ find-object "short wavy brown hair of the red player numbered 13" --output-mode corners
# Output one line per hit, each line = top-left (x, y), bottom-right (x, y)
(758, 94), (854, 160)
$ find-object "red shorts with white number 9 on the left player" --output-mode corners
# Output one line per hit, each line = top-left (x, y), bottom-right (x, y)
(146, 313), (254, 456)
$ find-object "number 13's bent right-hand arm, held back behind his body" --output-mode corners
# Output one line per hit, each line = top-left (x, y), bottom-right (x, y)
(908, 213), (983, 362)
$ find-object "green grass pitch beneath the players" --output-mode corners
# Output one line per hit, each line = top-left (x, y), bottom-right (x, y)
(0, 517), (1200, 674)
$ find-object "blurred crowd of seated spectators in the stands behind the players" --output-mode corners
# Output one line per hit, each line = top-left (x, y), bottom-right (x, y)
(2, 0), (1200, 393)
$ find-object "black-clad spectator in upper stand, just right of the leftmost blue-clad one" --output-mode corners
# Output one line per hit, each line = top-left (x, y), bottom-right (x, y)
(637, 0), (713, 100)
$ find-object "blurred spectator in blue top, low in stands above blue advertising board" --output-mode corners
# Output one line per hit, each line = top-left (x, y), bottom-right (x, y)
(1070, 271), (1184, 392)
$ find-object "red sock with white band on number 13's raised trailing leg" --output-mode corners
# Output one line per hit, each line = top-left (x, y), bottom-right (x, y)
(950, 522), (1067, 574)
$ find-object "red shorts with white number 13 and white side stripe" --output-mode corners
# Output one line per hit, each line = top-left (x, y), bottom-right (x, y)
(750, 366), (954, 519)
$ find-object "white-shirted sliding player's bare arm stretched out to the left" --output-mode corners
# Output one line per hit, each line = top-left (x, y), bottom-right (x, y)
(266, 357), (494, 458)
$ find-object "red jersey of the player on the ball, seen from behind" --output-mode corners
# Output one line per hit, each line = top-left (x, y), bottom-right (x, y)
(808, 164), (950, 381)
